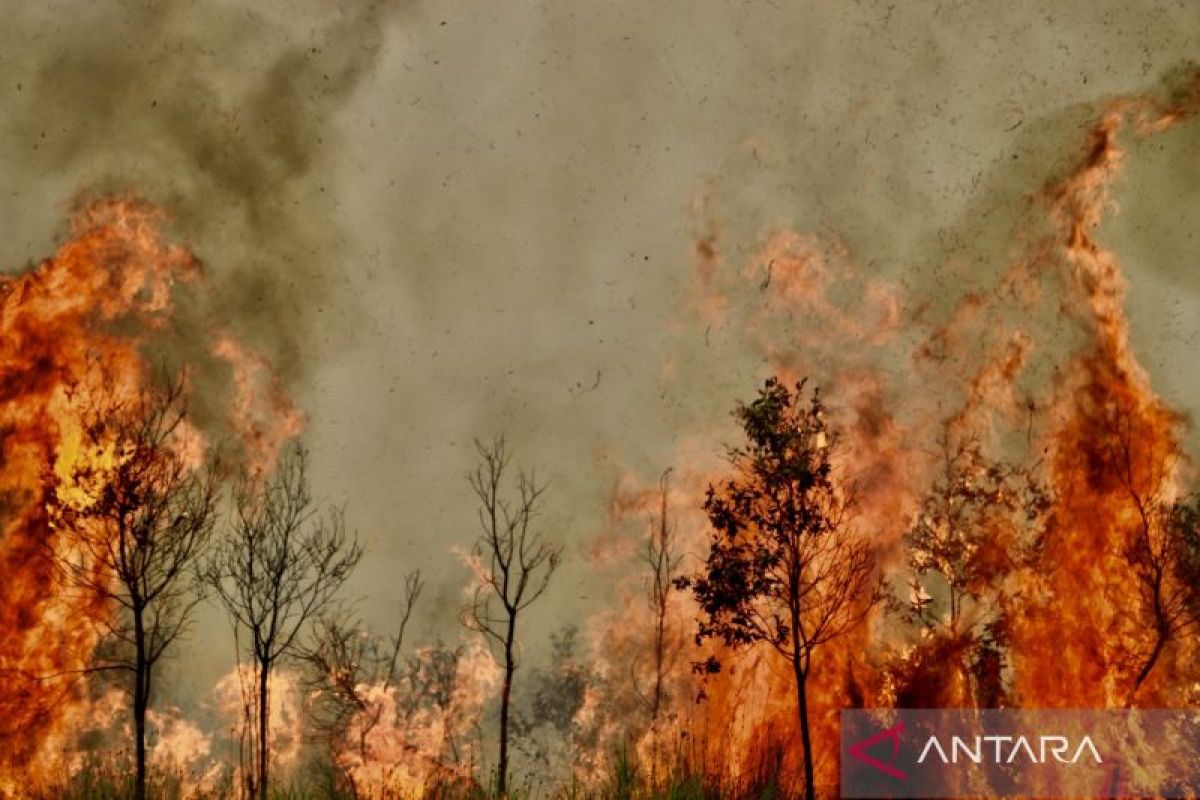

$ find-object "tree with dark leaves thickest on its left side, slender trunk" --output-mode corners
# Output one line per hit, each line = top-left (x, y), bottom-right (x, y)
(677, 378), (882, 800)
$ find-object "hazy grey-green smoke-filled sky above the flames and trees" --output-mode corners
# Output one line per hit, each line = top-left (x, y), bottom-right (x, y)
(0, 0), (1200, 710)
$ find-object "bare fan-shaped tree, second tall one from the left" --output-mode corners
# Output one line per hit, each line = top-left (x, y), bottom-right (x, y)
(205, 444), (362, 800)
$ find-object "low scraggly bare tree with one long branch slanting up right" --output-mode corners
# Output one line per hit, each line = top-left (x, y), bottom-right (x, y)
(299, 571), (425, 796)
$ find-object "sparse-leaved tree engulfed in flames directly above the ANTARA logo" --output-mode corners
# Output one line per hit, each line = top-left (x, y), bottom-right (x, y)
(905, 425), (1050, 705)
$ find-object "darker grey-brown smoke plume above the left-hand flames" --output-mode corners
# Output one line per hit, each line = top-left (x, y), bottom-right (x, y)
(0, 2), (408, 380)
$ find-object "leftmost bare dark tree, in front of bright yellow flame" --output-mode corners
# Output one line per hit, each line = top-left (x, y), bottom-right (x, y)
(49, 374), (220, 800)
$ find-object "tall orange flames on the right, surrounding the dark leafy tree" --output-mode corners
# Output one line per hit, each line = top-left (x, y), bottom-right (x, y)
(580, 71), (1200, 786)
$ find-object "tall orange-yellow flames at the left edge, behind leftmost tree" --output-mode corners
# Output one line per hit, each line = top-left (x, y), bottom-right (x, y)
(0, 197), (298, 794)
